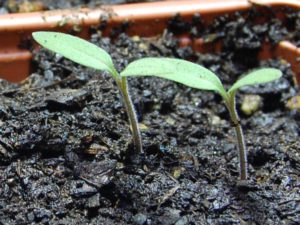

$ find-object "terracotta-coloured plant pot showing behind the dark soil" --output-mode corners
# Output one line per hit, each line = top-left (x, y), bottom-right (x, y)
(0, 0), (300, 82)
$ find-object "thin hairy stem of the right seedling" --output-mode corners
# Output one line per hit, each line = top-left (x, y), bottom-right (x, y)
(226, 96), (248, 180)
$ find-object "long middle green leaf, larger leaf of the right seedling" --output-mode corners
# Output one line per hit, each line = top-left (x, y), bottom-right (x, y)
(121, 57), (227, 97)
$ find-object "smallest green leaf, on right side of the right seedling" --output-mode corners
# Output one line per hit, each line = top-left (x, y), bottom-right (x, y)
(228, 68), (282, 93)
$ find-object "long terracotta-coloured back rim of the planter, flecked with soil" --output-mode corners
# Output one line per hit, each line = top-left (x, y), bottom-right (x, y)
(0, 0), (251, 33)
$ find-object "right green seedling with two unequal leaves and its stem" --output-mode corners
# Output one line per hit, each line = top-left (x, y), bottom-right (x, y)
(121, 58), (282, 180)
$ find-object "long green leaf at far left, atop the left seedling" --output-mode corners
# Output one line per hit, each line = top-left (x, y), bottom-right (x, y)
(32, 32), (118, 76)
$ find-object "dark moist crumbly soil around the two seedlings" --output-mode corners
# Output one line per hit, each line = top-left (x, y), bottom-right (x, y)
(0, 6), (300, 225)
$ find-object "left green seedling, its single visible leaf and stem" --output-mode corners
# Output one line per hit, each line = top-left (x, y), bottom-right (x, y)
(32, 32), (143, 153)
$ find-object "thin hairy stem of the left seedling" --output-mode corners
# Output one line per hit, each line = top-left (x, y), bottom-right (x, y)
(117, 77), (143, 153)
